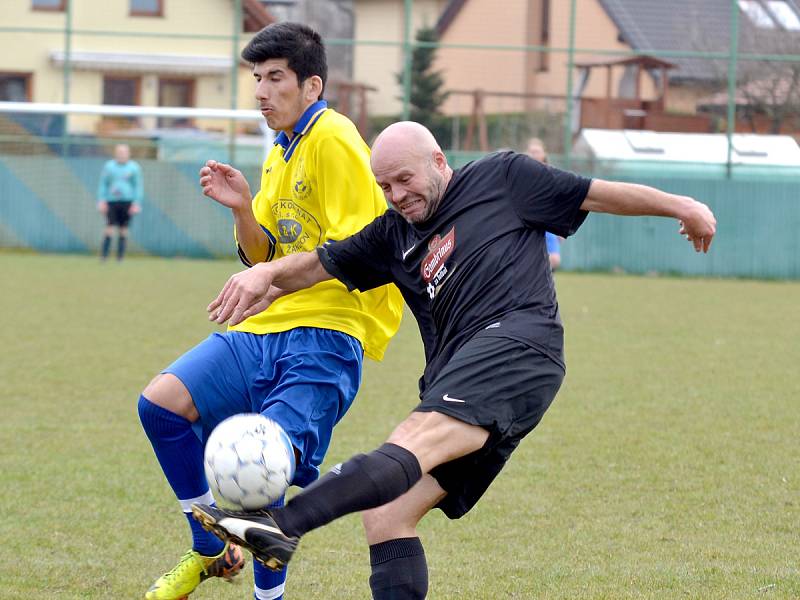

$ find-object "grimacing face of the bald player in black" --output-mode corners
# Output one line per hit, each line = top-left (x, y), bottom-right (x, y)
(372, 150), (446, 223)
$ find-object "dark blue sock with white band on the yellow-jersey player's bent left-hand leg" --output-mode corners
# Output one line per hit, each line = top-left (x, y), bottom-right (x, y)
(139, 396), (225, 556)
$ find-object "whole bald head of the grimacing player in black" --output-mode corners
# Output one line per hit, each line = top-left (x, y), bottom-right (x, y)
(370, 121), (453, 223)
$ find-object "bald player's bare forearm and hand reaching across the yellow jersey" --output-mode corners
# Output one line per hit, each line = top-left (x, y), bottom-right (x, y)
(207, 251), (333, 325)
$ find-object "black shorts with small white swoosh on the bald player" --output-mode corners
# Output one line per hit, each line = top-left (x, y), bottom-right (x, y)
(414, 335), (564, 519)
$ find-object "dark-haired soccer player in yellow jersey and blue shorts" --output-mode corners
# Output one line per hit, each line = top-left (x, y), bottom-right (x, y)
(139, 23), (402, 600)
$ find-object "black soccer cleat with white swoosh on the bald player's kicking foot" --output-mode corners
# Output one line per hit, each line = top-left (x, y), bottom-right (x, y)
(192, 503), (299, 571)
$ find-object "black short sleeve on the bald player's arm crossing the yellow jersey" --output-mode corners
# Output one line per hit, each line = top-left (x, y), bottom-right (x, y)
(317, 215), (393, 292)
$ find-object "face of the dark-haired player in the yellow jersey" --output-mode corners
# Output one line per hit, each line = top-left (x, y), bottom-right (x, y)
(253, 58), (311, 135)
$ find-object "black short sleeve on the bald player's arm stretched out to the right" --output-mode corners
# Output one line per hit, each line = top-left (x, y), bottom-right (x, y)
(506, 153), (591, 237)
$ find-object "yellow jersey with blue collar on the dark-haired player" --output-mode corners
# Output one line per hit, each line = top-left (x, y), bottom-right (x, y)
(230, 100), (403, 360)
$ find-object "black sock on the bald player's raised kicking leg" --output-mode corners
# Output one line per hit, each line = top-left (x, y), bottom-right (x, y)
(270, 444), (422, 537)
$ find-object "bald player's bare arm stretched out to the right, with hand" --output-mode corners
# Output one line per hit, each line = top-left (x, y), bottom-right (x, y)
(581, 179), (717, 252)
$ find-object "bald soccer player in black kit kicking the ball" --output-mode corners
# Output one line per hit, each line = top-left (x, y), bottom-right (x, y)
(193, 122), (716, 600)
